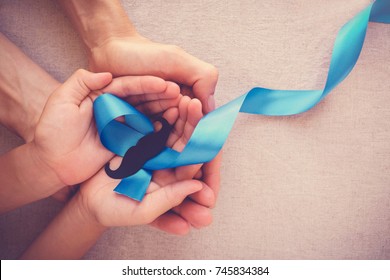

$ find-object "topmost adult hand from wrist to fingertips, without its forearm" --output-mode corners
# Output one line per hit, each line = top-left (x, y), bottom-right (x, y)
(89, 34), (218, 113)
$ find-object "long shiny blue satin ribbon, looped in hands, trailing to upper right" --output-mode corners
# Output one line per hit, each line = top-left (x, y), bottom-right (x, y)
(94, 0), (390, 201)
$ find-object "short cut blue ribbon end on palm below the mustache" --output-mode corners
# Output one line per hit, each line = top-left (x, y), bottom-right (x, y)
(114, 169), (152, 201)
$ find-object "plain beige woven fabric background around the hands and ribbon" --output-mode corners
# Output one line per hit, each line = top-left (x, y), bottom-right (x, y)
(0, 0), (390, 259)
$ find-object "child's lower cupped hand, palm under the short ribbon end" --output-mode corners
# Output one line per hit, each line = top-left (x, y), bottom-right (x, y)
(78, 97), (208, 230)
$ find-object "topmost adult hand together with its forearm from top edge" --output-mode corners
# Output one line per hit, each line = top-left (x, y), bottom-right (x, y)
(59, 0), (218, 113)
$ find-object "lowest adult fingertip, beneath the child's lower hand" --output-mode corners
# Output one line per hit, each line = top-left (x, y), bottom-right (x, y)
(150, 211), (191, 235)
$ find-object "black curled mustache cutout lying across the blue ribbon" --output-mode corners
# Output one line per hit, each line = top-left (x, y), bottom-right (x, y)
(104, 117), (173, 179)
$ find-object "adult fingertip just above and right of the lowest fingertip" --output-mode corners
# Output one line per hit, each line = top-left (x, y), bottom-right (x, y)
(173, 199), (213, 228)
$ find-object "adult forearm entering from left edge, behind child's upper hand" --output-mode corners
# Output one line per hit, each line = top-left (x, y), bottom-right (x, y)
(0, 34), (59, 142)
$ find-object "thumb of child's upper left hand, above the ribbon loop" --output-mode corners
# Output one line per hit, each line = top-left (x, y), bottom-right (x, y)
(57, 69), (112, 105)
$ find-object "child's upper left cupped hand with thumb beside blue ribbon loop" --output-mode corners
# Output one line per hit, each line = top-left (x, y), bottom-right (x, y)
(33, 70), (179, 190)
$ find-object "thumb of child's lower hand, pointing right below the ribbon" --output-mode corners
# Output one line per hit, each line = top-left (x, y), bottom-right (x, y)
(138, 180), (203, 224)
